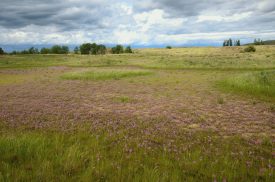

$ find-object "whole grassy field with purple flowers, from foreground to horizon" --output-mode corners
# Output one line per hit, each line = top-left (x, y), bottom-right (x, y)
(0, 46), (275, 181)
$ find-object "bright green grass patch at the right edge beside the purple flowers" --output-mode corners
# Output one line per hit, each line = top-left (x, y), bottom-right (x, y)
(218, 71), (275, 100)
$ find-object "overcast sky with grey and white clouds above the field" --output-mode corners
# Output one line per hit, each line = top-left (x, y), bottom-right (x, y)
(0, 0), (275, 46)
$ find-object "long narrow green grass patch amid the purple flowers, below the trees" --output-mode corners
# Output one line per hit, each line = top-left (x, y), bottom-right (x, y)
(61, 70), (152, 80)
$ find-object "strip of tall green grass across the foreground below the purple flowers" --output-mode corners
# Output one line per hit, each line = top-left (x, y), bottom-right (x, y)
(0, 126), (274, 181)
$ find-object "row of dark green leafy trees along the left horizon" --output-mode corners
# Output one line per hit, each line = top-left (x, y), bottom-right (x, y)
(0, 43), (133, 55)
